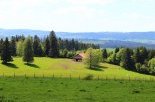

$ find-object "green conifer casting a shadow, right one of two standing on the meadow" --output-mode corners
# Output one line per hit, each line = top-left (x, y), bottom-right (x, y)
(23, 37), (34, 64)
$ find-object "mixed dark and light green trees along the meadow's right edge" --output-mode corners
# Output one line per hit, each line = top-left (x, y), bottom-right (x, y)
(102, 47), (155, 75)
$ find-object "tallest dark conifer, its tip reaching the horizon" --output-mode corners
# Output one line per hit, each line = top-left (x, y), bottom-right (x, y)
(49, 31), (59, 58)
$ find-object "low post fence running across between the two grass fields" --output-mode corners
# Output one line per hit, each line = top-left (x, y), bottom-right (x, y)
(0, 73), (155, 81)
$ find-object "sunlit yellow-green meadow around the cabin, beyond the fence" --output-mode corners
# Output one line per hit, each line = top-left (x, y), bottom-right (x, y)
(0, 57), (155, 80)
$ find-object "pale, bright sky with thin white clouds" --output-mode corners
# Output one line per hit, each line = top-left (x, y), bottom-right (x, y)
(0, 0), (155, 32)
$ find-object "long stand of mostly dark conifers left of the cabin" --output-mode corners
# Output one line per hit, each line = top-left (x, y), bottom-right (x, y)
(0, 31), (99, 64)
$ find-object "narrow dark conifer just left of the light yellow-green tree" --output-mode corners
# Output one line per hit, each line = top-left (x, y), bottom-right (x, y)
(10, 36), (16, 56)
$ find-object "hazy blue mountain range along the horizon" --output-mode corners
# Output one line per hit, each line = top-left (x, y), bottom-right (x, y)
(0, 29), (155, 48)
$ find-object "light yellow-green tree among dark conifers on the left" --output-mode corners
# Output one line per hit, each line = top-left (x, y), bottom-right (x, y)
(16, 40), (24, 57)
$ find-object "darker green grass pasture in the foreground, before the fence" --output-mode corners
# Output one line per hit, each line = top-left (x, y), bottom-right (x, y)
(0, 77), (155, 102)
